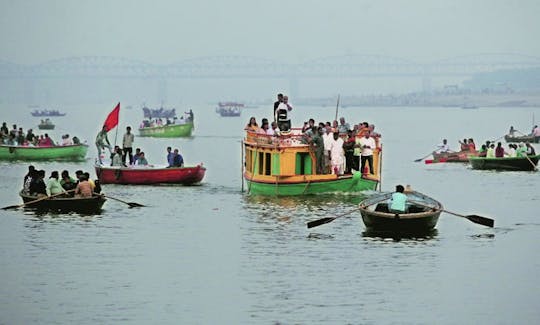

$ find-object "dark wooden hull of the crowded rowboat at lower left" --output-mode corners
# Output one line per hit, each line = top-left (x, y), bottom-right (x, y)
(19, 191), (107, 214)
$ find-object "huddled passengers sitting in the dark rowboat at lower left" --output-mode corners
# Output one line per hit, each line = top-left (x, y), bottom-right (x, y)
(23, 165), (101, 198)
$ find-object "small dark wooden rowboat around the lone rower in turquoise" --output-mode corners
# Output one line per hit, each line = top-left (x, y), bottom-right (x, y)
(359, 191), (443, 234)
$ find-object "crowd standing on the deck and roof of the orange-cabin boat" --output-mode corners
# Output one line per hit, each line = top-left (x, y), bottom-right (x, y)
(245, 94), (381, 175)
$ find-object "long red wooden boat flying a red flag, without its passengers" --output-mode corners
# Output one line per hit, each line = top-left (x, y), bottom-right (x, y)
(95, 163), (206, 185)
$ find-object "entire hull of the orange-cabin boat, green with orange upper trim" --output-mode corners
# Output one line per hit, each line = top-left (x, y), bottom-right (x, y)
(244, 172), (379, 196)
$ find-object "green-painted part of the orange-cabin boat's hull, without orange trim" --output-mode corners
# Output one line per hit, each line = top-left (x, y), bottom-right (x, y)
(246, 175), (378, 196)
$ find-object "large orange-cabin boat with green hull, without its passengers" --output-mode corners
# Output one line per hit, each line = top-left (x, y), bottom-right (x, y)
(243, 129), (381, 196)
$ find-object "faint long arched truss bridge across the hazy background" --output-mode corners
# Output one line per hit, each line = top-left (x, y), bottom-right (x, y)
(0, 53), (540, 80)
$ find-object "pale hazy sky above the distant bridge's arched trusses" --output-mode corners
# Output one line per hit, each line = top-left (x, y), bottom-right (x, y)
(0, 0), (540, 64)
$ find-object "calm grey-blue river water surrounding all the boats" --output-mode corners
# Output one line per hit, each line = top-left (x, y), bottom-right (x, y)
(0, 103), (540, 324)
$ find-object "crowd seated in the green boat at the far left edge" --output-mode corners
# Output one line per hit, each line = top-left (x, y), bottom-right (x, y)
(0, 122), (81, 147)
